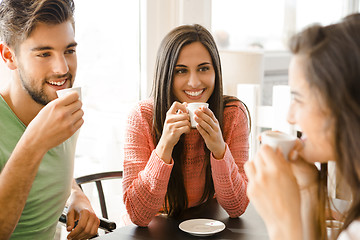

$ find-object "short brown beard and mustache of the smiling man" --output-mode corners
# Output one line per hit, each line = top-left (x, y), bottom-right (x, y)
(19, 69), (72, 106)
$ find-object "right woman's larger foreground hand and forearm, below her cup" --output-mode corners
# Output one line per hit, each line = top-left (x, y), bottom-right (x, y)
(244, 145), (302, 239)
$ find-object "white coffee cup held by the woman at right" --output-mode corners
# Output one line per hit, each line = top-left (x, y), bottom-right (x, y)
(261, 131), (296, 159)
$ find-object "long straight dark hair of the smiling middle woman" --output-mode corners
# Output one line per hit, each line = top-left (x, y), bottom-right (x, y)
(152, 24), (250, 217)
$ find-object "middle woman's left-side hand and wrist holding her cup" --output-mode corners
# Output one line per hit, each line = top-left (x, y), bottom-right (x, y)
(155, 102), (190, 163)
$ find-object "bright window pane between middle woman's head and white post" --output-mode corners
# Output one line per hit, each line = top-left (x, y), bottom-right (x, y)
(212, 0), (285, 50)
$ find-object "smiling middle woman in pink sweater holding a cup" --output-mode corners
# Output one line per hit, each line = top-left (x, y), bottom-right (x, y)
(123, 25), (249, 226)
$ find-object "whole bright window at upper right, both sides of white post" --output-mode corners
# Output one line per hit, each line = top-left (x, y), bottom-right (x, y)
(212, 0), (352, 51)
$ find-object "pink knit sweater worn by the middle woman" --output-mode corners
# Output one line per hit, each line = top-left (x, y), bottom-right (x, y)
(123, 100), (249, 226)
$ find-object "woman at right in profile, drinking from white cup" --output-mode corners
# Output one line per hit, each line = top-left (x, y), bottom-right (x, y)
(245, 14), (360, 240)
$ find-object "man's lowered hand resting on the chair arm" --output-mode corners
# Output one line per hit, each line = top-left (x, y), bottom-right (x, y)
(66, 183), (100, 239)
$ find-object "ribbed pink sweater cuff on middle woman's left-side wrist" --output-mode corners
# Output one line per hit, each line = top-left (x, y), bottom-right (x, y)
(145, 150), (174, 180)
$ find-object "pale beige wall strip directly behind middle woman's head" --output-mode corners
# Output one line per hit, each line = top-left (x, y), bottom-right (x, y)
(141, 0), (211, 98)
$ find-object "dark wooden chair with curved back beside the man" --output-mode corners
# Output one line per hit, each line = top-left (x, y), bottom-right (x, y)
(59, 171), (123, 232)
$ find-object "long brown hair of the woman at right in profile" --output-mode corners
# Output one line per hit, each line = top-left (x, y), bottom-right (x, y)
(290, 14), (360, 238)
